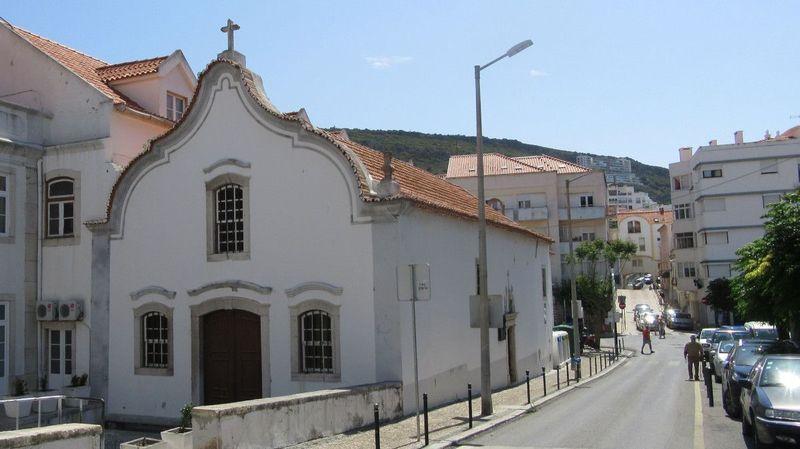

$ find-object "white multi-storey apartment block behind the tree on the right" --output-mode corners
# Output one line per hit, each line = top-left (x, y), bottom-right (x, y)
(669, 126), (800, 324)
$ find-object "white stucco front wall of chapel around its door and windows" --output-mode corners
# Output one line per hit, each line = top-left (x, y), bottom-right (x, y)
(108, 68), (375, 417)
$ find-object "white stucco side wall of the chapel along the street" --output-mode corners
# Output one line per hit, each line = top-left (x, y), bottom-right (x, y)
(375, 209), (552, 413)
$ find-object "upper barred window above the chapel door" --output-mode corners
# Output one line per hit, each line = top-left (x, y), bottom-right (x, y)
(214, 183), (245, 254)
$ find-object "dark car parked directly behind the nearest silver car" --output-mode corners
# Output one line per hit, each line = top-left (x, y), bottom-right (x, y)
(722, 340), (800, 418)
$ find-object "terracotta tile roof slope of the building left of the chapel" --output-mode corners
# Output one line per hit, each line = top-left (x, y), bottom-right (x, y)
(7, 24), (163, 119)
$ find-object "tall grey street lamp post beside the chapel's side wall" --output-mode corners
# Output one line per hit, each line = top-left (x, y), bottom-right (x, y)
(475, 40), (533, 416)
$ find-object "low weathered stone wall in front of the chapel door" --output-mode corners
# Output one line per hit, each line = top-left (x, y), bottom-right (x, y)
(192, 382), (403, 449)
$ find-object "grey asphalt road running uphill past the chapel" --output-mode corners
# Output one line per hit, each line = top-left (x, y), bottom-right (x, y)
(465, 290), (751, 449)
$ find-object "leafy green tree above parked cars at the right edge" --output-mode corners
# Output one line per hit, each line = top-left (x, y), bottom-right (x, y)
(732, 190), (800, 338)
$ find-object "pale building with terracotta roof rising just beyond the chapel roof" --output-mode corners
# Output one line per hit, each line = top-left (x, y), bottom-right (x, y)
(446, 153), (608, 282)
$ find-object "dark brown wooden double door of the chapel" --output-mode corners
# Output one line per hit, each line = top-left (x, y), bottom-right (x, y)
(202, 309), (262, 405)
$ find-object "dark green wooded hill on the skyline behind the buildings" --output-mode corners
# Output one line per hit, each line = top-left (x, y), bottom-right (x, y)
(347, 129), (670, 204)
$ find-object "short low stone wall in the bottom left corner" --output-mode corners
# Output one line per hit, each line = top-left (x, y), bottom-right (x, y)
(0, 424), (103, 449)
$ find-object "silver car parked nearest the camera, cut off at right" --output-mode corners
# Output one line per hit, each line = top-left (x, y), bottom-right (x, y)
(740, 355), (800, 447)
